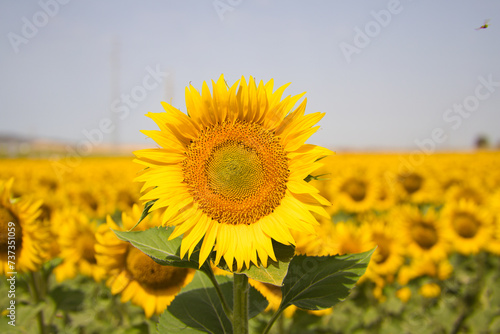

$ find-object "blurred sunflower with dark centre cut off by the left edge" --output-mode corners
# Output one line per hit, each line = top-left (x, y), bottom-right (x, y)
(0, 178), (50, 276)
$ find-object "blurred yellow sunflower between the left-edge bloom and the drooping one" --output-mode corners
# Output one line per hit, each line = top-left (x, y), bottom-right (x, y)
(54, 208), (106, 282)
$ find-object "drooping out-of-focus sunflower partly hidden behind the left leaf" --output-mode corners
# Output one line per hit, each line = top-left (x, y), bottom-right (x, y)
(95, 205), (195, 318)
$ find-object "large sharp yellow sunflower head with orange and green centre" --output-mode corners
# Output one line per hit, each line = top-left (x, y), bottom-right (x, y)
(135, 76), (331, 270)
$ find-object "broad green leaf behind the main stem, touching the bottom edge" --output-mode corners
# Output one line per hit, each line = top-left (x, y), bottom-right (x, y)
(157, 272), (268, 334)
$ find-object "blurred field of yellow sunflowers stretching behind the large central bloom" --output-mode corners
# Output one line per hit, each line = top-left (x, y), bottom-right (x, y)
(0, 151), (500, 334)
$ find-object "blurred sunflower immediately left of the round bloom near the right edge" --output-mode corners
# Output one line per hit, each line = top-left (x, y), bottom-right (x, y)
(395, 205), (449, 260)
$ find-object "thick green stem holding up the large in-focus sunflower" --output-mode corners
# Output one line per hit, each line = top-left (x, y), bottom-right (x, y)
(233, 273), (250, 334)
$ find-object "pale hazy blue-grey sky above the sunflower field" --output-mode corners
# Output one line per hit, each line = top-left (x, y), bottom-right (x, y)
(0, 0), (500, 149)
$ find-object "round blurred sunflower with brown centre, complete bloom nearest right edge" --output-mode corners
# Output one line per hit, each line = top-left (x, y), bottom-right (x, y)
(442, 200), (494, 255)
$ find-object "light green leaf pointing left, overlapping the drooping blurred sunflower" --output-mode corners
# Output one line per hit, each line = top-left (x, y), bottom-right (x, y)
(113, 227), (199, 269)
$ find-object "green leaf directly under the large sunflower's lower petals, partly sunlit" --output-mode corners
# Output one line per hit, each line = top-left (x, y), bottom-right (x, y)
(214, 240), (295, 286)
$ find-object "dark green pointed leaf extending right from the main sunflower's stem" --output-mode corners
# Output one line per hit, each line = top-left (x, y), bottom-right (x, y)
(280, 248), (375, 310)
